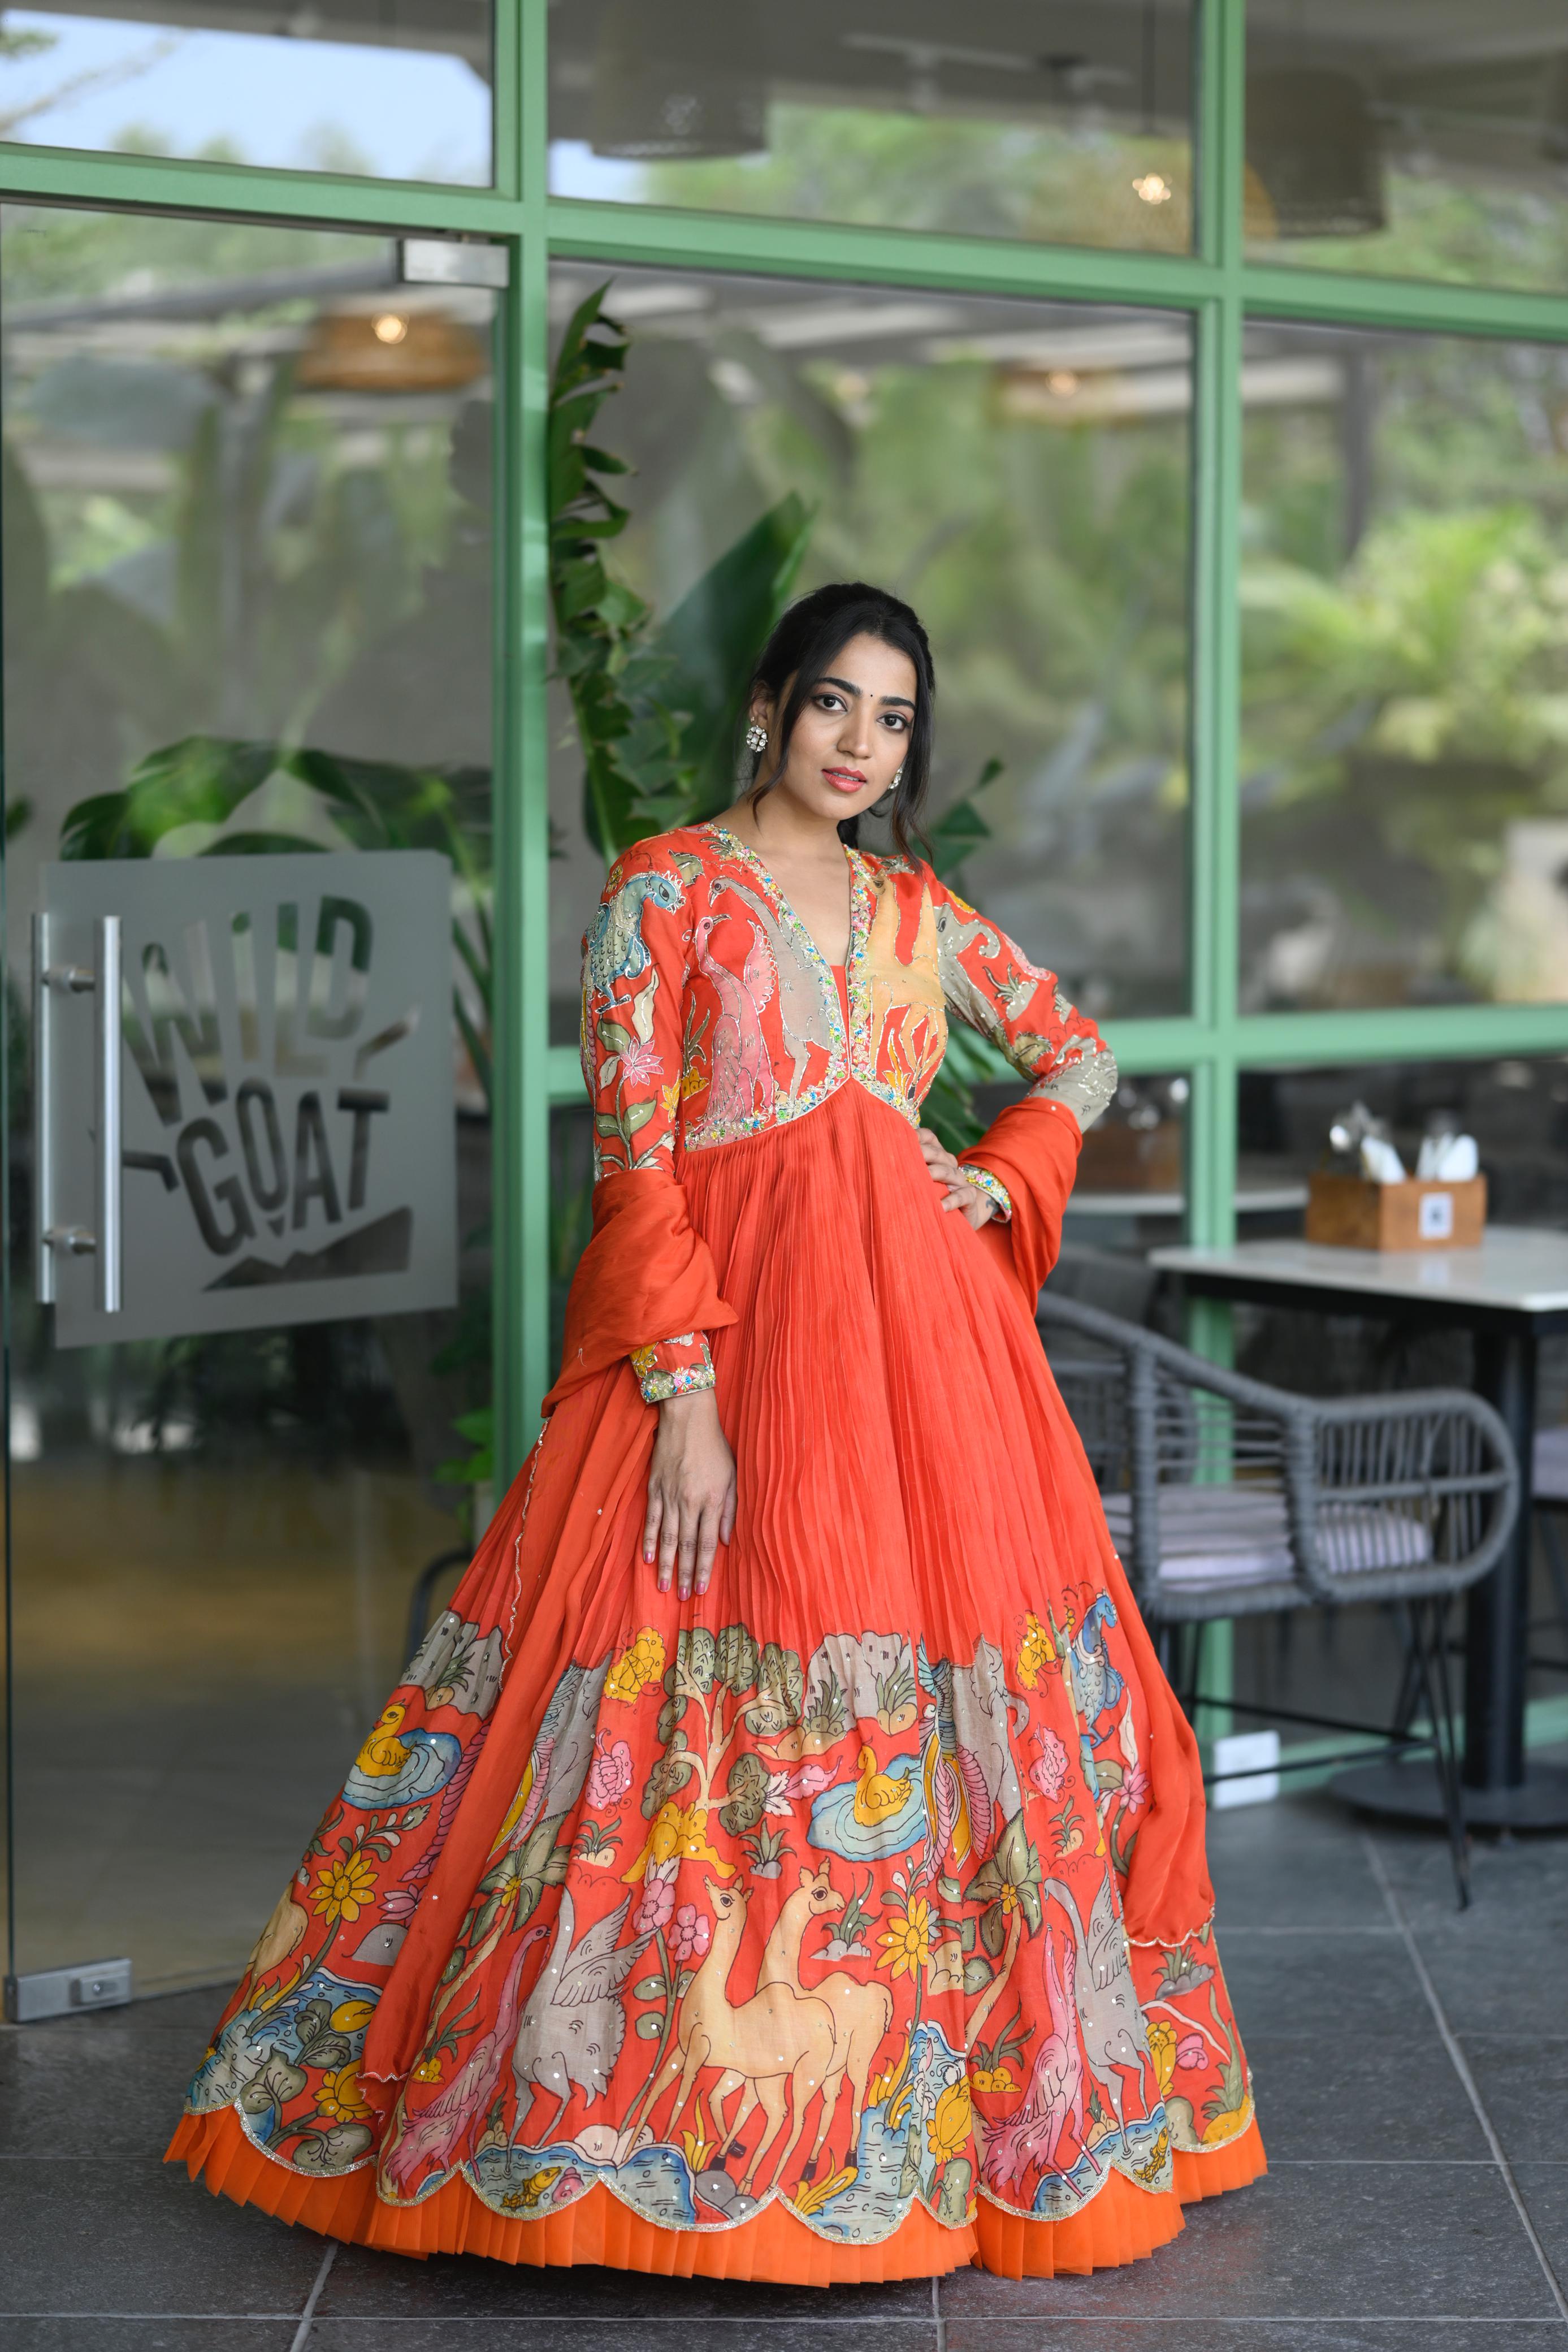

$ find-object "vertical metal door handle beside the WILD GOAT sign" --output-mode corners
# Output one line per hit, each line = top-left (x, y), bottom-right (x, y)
(33, 915), (124, 1315)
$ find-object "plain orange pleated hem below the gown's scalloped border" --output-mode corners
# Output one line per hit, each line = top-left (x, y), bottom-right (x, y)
(164, 2107), (1267, 2286)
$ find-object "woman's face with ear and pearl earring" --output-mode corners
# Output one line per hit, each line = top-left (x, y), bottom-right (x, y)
(752, 637), (919, 825)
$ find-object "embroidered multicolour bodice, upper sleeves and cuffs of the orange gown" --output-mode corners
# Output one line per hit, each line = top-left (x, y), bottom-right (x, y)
(583, 823), (1116, 1395)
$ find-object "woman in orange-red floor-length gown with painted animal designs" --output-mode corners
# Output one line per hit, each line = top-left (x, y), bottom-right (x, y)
(169, 583), (1262, 2284)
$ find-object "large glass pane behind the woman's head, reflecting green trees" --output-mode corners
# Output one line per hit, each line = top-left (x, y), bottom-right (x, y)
(550, 266), (1192, 1042)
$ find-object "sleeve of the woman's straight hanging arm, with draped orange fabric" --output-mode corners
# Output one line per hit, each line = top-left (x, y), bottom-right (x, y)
(545, 842), (736, 1404)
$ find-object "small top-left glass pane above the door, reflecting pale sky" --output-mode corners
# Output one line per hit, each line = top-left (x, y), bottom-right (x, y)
(0, 0), (493, 188)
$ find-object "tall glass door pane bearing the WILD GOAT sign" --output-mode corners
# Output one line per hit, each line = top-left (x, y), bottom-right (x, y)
(0, 209), (493, 1990)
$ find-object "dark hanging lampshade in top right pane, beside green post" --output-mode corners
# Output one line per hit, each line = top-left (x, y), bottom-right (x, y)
(1246, 66), (1387, 237)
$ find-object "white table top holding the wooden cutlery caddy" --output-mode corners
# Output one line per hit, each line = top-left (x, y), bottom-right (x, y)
(1150, 1225), (1568, 1315)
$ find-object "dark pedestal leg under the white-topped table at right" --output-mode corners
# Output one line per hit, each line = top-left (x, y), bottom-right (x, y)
(1465, 1326), (1535, 1792)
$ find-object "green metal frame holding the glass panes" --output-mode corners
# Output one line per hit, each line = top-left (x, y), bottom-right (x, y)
(0, 0), (1568, 1475)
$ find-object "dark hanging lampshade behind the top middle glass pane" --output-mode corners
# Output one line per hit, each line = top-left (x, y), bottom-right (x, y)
(592, 0), (769, 162)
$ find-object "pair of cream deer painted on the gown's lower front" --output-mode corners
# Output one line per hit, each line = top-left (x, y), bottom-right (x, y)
(656, 1879), (834, 2197)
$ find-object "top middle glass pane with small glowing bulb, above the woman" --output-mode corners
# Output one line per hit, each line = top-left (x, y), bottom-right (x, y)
(550, 0), (1194, 252)
